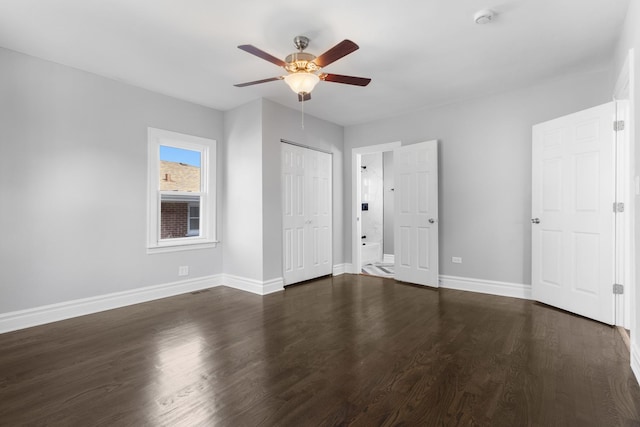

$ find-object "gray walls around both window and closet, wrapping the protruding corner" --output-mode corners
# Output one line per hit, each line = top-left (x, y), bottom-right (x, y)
(0, 45), (344, 313)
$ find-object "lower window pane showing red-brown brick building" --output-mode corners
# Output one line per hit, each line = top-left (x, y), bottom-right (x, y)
(160, 194), (200, 239)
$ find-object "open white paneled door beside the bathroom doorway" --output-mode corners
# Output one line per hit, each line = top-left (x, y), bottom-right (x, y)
(393, 141), (438, 287)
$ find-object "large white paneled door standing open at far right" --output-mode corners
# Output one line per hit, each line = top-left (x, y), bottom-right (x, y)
(531, 103), (615, 324)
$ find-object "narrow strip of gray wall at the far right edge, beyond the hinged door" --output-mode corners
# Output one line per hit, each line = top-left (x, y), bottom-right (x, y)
(611, 1), (640, 368)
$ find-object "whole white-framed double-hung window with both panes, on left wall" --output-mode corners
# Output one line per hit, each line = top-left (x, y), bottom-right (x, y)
(147, 128), (216, 253)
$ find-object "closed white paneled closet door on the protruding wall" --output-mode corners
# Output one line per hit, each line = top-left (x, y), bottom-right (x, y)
(282, 143), (333, 285)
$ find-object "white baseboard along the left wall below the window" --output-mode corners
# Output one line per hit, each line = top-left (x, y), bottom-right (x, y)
(0, 274), (222, 333)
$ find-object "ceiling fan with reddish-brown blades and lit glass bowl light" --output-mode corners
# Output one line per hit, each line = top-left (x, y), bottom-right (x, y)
(234, 36), (371, 101)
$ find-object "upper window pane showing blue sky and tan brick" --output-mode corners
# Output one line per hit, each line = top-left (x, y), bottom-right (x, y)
(160, 145), (202, 192)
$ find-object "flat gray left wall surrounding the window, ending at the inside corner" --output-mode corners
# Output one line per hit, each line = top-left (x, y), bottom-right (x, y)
(0, 49), (223, 313)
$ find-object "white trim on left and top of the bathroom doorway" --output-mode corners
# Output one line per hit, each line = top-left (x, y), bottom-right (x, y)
(351, 141), (402, 274)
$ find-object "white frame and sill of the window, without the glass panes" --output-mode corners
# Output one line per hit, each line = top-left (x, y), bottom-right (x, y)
(147, 127), (217, 253)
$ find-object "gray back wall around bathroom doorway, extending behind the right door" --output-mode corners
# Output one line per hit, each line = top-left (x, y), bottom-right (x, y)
(344, 69), (611, 284)
